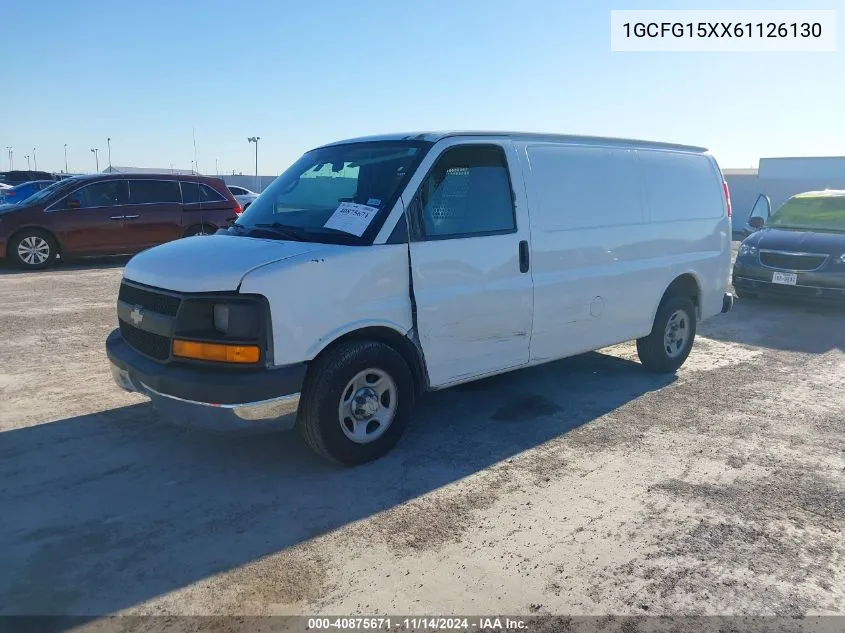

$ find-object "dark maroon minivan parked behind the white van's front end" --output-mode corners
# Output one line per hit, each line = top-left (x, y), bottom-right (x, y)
(0, 174), (241, 269)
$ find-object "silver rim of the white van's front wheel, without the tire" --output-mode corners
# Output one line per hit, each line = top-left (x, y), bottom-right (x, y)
(338, 369), (399, 444)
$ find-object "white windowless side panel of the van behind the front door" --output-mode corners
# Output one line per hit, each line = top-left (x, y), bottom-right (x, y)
(518, 142), (730, 361)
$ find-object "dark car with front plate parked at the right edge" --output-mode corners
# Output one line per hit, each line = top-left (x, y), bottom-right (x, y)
(732, 190), (845, 301)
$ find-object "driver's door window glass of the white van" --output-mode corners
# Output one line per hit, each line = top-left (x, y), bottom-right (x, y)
(416, 145), (516, 239)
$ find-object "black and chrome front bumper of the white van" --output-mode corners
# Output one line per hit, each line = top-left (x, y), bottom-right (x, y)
(106, 329), (306, 433)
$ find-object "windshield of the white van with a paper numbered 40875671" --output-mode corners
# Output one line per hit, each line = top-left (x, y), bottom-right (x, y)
(231, 141), (431, 244)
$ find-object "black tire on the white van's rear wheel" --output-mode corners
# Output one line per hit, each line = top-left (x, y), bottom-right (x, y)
(637, 295), (696, 374)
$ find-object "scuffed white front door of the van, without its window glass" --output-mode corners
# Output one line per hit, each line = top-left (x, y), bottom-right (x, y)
(404, 139), (534, 386)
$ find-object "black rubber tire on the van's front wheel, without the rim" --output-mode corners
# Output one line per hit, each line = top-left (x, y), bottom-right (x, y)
(296, 340), (415, 466)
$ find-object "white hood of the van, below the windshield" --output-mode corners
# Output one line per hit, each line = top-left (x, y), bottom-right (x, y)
(123, 235), (325, 292)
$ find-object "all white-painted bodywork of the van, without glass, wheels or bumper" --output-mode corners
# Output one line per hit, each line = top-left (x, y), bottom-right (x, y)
(120, 129), (731, 388)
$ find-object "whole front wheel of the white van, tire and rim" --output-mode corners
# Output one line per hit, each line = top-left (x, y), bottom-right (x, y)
(297, 341), (414, 466)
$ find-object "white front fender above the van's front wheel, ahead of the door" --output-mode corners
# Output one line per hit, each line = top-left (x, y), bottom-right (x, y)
(240, 244), (412, 365)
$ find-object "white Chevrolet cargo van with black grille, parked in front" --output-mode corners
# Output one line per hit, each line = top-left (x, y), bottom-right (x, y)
(106, 132), (733, 465)
